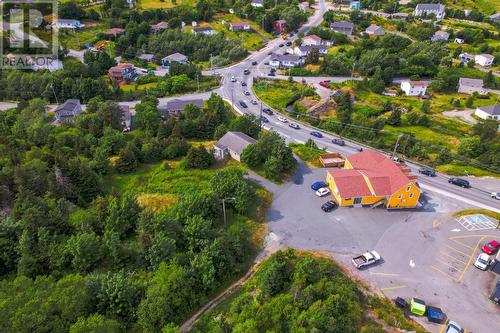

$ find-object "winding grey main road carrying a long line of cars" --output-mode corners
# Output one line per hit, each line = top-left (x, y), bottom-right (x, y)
(205, 0), (500, 213)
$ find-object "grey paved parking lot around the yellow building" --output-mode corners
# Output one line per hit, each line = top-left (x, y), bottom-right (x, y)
(258, 160), (500, 332)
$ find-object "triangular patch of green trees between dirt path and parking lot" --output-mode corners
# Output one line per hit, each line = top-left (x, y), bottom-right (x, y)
(193, 249), (424, 333)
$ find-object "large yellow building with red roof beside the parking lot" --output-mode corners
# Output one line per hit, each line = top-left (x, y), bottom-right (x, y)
(326, 150), (422, 209)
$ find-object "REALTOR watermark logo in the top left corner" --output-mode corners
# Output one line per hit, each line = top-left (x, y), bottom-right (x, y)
(0, 0), (59, 69)
